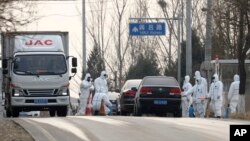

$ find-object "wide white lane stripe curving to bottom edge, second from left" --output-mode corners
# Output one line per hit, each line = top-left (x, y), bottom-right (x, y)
(30, 118), (90, 141)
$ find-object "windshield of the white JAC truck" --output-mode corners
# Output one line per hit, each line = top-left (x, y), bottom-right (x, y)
(13, 54), (67, 75)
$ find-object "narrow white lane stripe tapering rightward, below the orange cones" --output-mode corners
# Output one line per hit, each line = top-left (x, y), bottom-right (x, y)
(71, 116), (130, 126)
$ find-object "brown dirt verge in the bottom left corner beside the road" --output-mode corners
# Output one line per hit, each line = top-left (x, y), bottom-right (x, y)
(0, 118), (35, 141)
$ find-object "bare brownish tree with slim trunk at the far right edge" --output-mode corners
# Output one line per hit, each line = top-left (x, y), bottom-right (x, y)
(215, 0), (250, 112)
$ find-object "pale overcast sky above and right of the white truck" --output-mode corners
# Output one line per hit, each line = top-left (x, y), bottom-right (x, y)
(20, 0), (161, 96)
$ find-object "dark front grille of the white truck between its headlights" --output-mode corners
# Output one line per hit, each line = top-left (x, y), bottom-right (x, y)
(24, 89), (57, 96)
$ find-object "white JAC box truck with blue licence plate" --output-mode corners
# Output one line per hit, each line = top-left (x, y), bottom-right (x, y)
(1, 31), (77, 117)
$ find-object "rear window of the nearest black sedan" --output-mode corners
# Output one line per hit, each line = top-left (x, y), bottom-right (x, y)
(143, 77), (179, 86)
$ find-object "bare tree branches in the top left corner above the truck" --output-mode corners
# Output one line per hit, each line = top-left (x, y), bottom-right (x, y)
(0, 0), (35, 31)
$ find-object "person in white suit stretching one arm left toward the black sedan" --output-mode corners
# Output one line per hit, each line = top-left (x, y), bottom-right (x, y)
(184, 77), (206, 117)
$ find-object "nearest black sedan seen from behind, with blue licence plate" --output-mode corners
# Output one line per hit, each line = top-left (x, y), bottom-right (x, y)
(134, 76), (182, 117)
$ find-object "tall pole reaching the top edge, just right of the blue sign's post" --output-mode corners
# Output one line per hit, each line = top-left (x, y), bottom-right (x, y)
(186, 0), (192, 76)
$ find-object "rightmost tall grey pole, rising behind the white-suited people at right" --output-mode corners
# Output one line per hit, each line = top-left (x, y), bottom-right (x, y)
(203, 0), (212, 83)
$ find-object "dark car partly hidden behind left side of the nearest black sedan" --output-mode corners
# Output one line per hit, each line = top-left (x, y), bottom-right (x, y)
(120, 79), (141, 115)
